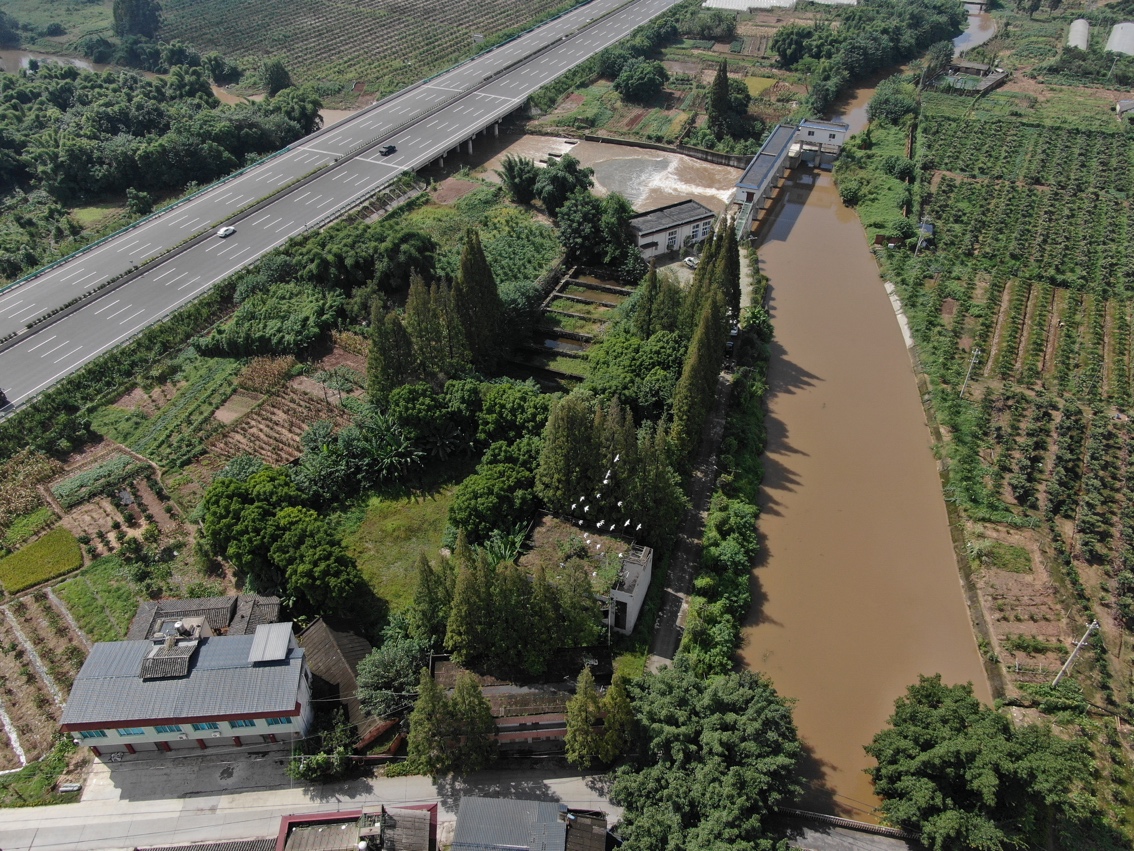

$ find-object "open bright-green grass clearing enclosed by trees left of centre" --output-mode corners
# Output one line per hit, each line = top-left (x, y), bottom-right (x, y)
(344, 485), (456, 612)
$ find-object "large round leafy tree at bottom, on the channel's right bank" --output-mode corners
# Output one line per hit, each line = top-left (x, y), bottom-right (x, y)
(865, 674), (1091, 851)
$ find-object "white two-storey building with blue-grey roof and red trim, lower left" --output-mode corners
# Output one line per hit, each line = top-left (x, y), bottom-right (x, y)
(60, 617), (313, 756)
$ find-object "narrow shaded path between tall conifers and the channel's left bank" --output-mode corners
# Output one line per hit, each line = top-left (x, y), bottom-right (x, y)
(645, 372), (733, 671)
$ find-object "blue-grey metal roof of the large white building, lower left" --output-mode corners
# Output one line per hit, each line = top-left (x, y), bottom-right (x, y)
(61, 635), (303, 728)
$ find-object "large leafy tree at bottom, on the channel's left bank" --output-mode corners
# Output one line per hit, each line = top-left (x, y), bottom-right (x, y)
(611, 667), (803, 851)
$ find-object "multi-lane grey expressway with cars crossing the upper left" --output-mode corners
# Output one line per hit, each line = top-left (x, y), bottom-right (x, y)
(0, 0), (677, 411)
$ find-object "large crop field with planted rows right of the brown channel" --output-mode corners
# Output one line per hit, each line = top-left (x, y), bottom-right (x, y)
(870, 86), (1134, 835)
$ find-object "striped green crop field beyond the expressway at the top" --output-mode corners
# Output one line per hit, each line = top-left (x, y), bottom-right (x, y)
(162, 0), (573, 93)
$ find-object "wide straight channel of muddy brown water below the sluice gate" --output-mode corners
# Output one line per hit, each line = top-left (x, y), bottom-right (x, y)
(742, 16), (991, 820)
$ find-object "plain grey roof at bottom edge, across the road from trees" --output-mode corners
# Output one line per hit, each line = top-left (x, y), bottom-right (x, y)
(451, 797), (567, 851)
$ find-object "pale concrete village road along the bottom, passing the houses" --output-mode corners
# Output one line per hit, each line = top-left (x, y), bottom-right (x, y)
(0, 748), (917, 851)
